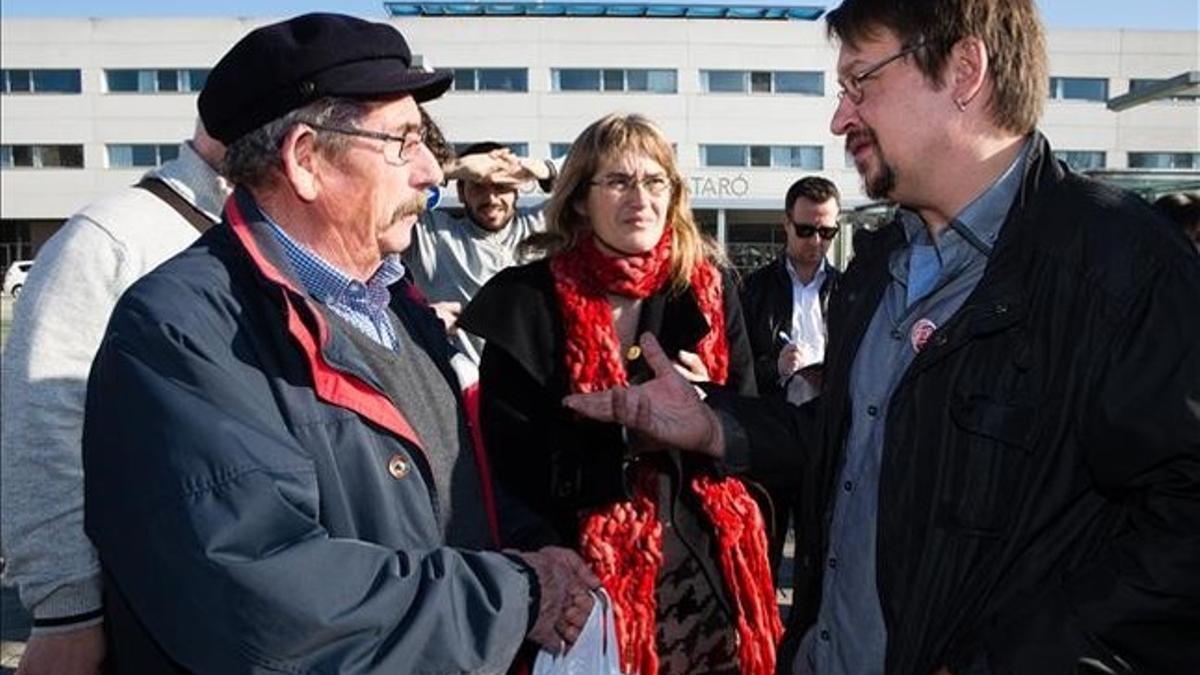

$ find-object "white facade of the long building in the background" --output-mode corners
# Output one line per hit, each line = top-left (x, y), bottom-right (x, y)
(0, 17), (1200, 219)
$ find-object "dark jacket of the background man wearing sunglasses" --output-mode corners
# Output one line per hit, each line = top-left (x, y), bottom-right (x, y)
(742, 253), (841, 396)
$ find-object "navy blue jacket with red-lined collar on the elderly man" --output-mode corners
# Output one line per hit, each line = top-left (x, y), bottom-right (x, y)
(83, 190), (536, 675)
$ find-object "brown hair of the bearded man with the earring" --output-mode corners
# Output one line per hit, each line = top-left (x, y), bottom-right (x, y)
(826, 0), (1050, 136)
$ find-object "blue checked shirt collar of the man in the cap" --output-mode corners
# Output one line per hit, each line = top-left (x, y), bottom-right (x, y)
(266, 219), (404, 351)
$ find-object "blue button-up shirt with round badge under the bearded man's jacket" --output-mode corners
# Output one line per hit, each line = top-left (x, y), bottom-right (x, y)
(792, 142), (1030, 675)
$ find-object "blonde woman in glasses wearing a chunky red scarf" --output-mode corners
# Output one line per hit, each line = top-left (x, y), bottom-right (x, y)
(460, 115), (781, 675)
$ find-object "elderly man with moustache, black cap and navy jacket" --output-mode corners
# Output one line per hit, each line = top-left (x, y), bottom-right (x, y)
(83, 14), (598, 674)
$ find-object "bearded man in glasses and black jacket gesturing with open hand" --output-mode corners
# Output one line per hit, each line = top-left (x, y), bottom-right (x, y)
(568, 0), (1200, 675)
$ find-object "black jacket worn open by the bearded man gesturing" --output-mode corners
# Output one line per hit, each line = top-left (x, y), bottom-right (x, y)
(720, 132), (1200, 675)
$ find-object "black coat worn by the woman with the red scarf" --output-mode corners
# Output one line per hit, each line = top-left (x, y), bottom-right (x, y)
(458, 261), (755, 545)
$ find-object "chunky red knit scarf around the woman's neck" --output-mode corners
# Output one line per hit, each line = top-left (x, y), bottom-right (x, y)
(550, 227), (782, 675)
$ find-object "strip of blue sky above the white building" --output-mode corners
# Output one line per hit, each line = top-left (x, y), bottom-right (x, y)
(0, 0), (1200, 30)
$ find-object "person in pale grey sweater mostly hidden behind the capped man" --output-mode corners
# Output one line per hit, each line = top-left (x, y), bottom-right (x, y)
(0, 120), (230, 675)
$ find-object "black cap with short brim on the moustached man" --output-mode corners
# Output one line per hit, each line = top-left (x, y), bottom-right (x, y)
(197, 13), (454, 145)
